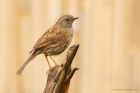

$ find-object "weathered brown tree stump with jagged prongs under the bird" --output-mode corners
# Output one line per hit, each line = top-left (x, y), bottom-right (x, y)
(43, 44), (79, 93)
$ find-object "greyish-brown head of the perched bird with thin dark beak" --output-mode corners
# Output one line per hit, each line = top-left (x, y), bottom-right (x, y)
(56, 15), (78, 28)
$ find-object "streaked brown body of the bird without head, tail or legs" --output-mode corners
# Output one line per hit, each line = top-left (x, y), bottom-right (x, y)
(30, 26), (73, 55)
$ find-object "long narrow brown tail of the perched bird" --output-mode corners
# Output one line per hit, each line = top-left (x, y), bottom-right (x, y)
(16, 52), (37, 75)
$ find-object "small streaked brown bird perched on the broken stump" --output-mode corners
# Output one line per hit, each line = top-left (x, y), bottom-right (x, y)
(16, 15), (78, 75)
